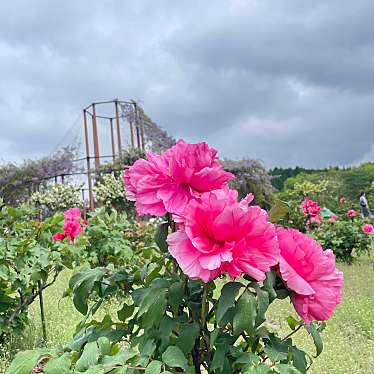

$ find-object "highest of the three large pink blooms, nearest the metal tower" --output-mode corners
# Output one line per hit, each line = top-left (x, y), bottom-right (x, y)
(124, 140), (234, 216)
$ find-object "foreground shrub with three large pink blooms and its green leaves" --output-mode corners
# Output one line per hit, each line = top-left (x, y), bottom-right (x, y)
(8, 142), (343, 374)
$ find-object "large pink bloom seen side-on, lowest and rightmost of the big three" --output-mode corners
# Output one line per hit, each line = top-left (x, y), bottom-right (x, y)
(278, 229), (343, 324)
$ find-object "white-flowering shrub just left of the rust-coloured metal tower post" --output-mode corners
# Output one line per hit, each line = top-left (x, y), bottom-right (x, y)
(28, 184), (83, 215)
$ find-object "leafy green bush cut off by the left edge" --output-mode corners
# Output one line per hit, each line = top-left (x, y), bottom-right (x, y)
(0, 205), (79, 342)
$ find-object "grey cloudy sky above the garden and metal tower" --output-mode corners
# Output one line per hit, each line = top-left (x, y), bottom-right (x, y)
(0, 0), (374, 167)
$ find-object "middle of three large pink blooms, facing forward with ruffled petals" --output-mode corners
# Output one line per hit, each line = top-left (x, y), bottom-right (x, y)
(167, 189), (279, 282)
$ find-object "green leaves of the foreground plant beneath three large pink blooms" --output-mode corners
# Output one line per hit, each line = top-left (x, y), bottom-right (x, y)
(8, 219), (328, 374)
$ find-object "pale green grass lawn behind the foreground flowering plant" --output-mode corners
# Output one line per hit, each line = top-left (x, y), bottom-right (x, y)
(0, 258), (374, 374)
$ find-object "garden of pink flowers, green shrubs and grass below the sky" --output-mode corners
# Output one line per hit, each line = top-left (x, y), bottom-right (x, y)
(0, 140), (374, 374)
